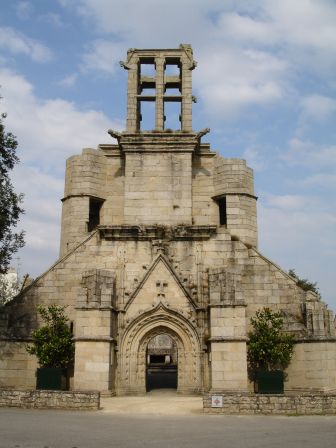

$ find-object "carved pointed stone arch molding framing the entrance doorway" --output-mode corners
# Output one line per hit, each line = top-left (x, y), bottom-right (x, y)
(117, 303), (202, 394)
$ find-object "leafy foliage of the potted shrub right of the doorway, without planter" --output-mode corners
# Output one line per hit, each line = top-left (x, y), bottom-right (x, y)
(247, 308), (294, 373)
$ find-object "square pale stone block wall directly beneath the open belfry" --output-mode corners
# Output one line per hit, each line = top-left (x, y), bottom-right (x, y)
(124, 153), (192, 225)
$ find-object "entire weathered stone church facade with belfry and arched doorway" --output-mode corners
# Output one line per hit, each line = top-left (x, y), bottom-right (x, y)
(0, 45), (336, 395)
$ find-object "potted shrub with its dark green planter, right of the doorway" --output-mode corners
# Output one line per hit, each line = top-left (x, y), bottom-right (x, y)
(247, 308), (294, 394)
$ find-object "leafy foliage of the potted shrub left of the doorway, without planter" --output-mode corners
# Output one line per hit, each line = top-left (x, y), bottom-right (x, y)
(26, 305), (75, 368)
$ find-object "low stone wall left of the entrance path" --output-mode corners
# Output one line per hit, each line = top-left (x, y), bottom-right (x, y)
(0, 389), (100, 411)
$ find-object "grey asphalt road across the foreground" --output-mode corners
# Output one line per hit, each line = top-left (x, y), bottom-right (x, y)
(0, 408), (336, 448)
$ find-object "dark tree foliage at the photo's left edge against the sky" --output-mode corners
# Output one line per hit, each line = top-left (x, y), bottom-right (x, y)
(0, 110), (24, 274)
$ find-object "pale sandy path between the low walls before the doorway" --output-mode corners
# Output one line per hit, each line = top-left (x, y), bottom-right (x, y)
(100, 389), (203, 415)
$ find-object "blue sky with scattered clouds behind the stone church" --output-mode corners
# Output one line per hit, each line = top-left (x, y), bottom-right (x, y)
(0, 0), (336, 310)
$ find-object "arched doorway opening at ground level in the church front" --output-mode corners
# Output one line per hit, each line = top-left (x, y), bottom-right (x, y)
(146, 332), (178, 392)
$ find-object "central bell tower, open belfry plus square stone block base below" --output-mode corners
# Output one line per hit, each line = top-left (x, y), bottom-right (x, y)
(109, 44), (207, 226)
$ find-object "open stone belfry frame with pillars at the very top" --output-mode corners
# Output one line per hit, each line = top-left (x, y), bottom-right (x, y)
(121, 44), (196, 133)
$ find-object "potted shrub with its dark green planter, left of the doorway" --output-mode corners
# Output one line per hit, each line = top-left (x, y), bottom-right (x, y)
(26, 305), (75, 390)
